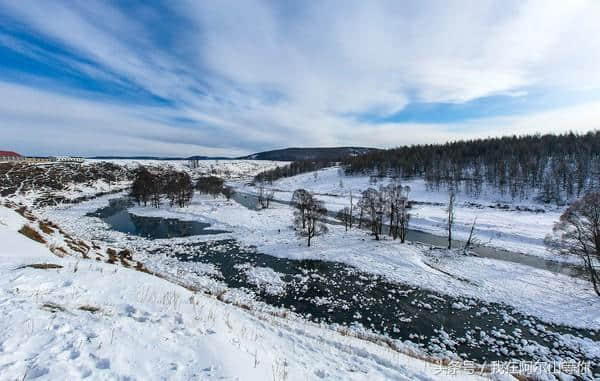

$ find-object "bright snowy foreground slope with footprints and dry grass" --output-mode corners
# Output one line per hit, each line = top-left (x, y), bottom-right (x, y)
(0, 207), (490, 380)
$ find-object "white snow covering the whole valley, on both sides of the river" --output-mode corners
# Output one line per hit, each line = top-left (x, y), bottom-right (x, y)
(0, 160), (600, 380)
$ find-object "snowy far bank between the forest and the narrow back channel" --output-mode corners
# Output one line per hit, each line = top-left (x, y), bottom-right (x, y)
(240, 167), (577, 262)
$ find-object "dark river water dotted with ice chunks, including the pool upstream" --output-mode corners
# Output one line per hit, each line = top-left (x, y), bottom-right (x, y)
(90, 200), (600, 377)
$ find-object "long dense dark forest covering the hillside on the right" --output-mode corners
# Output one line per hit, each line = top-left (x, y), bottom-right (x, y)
(343, 131), (600, 203)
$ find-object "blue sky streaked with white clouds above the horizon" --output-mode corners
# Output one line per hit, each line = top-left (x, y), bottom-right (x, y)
(0, 0), (600, 156)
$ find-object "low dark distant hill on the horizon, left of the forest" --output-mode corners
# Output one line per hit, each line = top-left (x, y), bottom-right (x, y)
(238, 147), (378, 161)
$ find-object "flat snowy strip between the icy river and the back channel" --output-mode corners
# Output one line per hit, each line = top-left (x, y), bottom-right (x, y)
(48, 190), (600, 329)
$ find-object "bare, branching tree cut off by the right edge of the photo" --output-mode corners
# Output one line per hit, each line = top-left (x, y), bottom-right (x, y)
(546, 191), (600, 296)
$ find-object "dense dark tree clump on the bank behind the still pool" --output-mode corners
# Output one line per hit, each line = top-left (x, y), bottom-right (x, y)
(130, 167), (194, 208)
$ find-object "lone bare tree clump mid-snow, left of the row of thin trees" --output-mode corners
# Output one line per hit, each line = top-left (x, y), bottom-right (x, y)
(292, 189), (328, 246)
